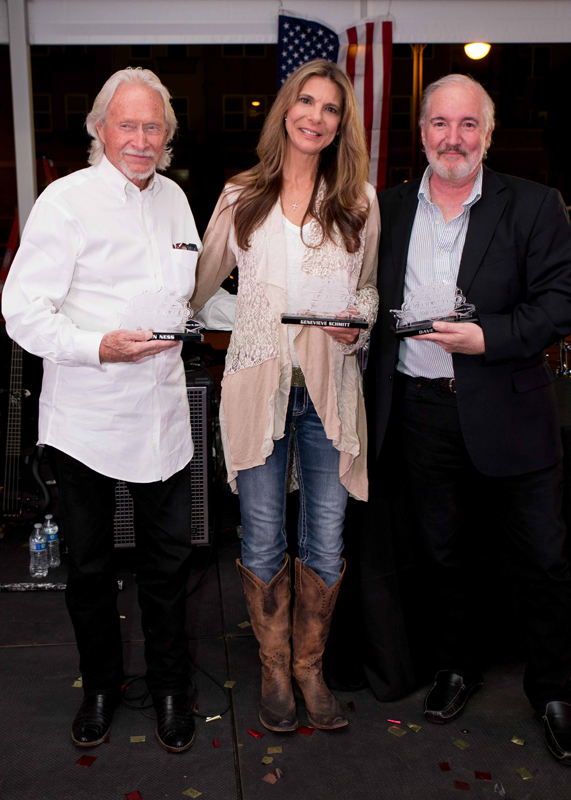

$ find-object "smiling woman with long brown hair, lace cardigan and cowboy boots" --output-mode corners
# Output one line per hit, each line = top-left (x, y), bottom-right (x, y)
(192, 60), (380, 731)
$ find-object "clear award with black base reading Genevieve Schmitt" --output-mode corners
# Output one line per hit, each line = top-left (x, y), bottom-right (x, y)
(281, 276), (369, 328)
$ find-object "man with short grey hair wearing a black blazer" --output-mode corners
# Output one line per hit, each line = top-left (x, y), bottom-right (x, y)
(366, 75), (571, 765)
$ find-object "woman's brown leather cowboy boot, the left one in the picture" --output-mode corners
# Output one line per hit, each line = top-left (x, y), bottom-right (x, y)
(236, 554), (299, 731)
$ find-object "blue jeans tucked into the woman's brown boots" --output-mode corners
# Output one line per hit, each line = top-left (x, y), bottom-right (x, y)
(237, 387), (347, 587)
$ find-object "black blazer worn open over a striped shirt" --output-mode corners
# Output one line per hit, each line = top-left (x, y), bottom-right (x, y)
(365, 168), (571, 476)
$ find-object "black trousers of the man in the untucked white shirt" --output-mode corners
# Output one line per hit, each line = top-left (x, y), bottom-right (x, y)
(49, 447), (191, 697)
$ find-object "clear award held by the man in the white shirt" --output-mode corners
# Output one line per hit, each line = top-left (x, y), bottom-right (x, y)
(121, 288), (204, 342)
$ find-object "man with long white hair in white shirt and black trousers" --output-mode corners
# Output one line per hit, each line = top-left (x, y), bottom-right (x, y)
(3, 68), (200, 752)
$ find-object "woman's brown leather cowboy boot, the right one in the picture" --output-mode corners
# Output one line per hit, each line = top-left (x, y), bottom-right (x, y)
(293, 558), (349, 730)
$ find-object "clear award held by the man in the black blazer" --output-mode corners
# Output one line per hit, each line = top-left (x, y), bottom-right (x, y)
(391, 281), (478, 336)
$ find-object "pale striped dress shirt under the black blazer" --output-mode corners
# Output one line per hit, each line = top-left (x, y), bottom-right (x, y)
(397, 166), (483, 378)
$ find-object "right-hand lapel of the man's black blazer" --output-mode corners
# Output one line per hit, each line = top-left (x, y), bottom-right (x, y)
(458, 167), (508, 295)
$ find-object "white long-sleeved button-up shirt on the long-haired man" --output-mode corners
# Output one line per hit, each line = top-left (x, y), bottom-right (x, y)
(2, 158), (200, 483)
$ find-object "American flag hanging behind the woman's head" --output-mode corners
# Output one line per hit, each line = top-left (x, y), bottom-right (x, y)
(278, 14), (393, 191)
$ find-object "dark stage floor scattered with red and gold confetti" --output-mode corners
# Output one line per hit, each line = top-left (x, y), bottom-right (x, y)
(0, 510), (571, 800)
